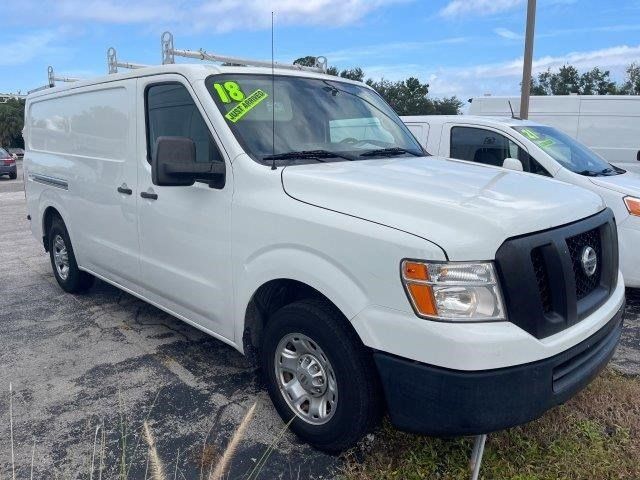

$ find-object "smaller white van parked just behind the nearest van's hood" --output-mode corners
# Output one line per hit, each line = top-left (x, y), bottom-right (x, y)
(402, 115), (640, 287)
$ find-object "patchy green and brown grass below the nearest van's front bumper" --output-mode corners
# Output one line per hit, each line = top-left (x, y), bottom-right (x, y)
(342, 371), (640, 480)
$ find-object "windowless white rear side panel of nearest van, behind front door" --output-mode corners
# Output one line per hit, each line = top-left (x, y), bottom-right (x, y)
(27, 80), (138, 286)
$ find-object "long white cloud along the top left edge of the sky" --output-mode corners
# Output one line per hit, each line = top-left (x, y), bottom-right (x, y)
(3, 0), (414, 32)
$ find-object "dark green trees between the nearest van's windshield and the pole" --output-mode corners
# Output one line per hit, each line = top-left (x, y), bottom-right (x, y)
(293, 56), (463, 115)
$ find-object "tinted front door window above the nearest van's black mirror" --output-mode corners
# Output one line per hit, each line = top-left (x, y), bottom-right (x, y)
(145, 82), (223, 163)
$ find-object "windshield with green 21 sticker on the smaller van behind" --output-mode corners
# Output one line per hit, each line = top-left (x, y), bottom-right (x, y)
(513, 125), (622, 177)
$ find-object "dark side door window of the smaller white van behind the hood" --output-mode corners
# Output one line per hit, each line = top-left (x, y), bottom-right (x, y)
(450, 127), (551, 177)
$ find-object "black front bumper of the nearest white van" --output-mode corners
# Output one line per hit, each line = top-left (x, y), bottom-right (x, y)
(374, 304), (624, 436)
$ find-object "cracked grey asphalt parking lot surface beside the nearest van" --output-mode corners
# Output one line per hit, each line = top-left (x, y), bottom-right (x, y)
(0, 170), (640, 479)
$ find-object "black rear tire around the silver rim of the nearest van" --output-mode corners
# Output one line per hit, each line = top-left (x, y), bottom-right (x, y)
(47, 217), (95, 293)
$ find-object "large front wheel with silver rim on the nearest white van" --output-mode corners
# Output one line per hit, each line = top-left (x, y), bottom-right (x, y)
(261, 300), (382, 452)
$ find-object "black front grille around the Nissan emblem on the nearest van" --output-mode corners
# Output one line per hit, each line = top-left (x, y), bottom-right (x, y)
(496, 209), (618, 338)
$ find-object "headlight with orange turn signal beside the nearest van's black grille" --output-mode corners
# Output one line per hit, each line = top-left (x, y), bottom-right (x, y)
(401, 260), (506, 322)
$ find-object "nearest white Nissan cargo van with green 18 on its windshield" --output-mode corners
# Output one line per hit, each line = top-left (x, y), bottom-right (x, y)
(24, 54), (625, 451)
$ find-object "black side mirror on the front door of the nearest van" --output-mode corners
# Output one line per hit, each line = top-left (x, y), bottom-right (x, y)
(151, 137), (225, 188)
